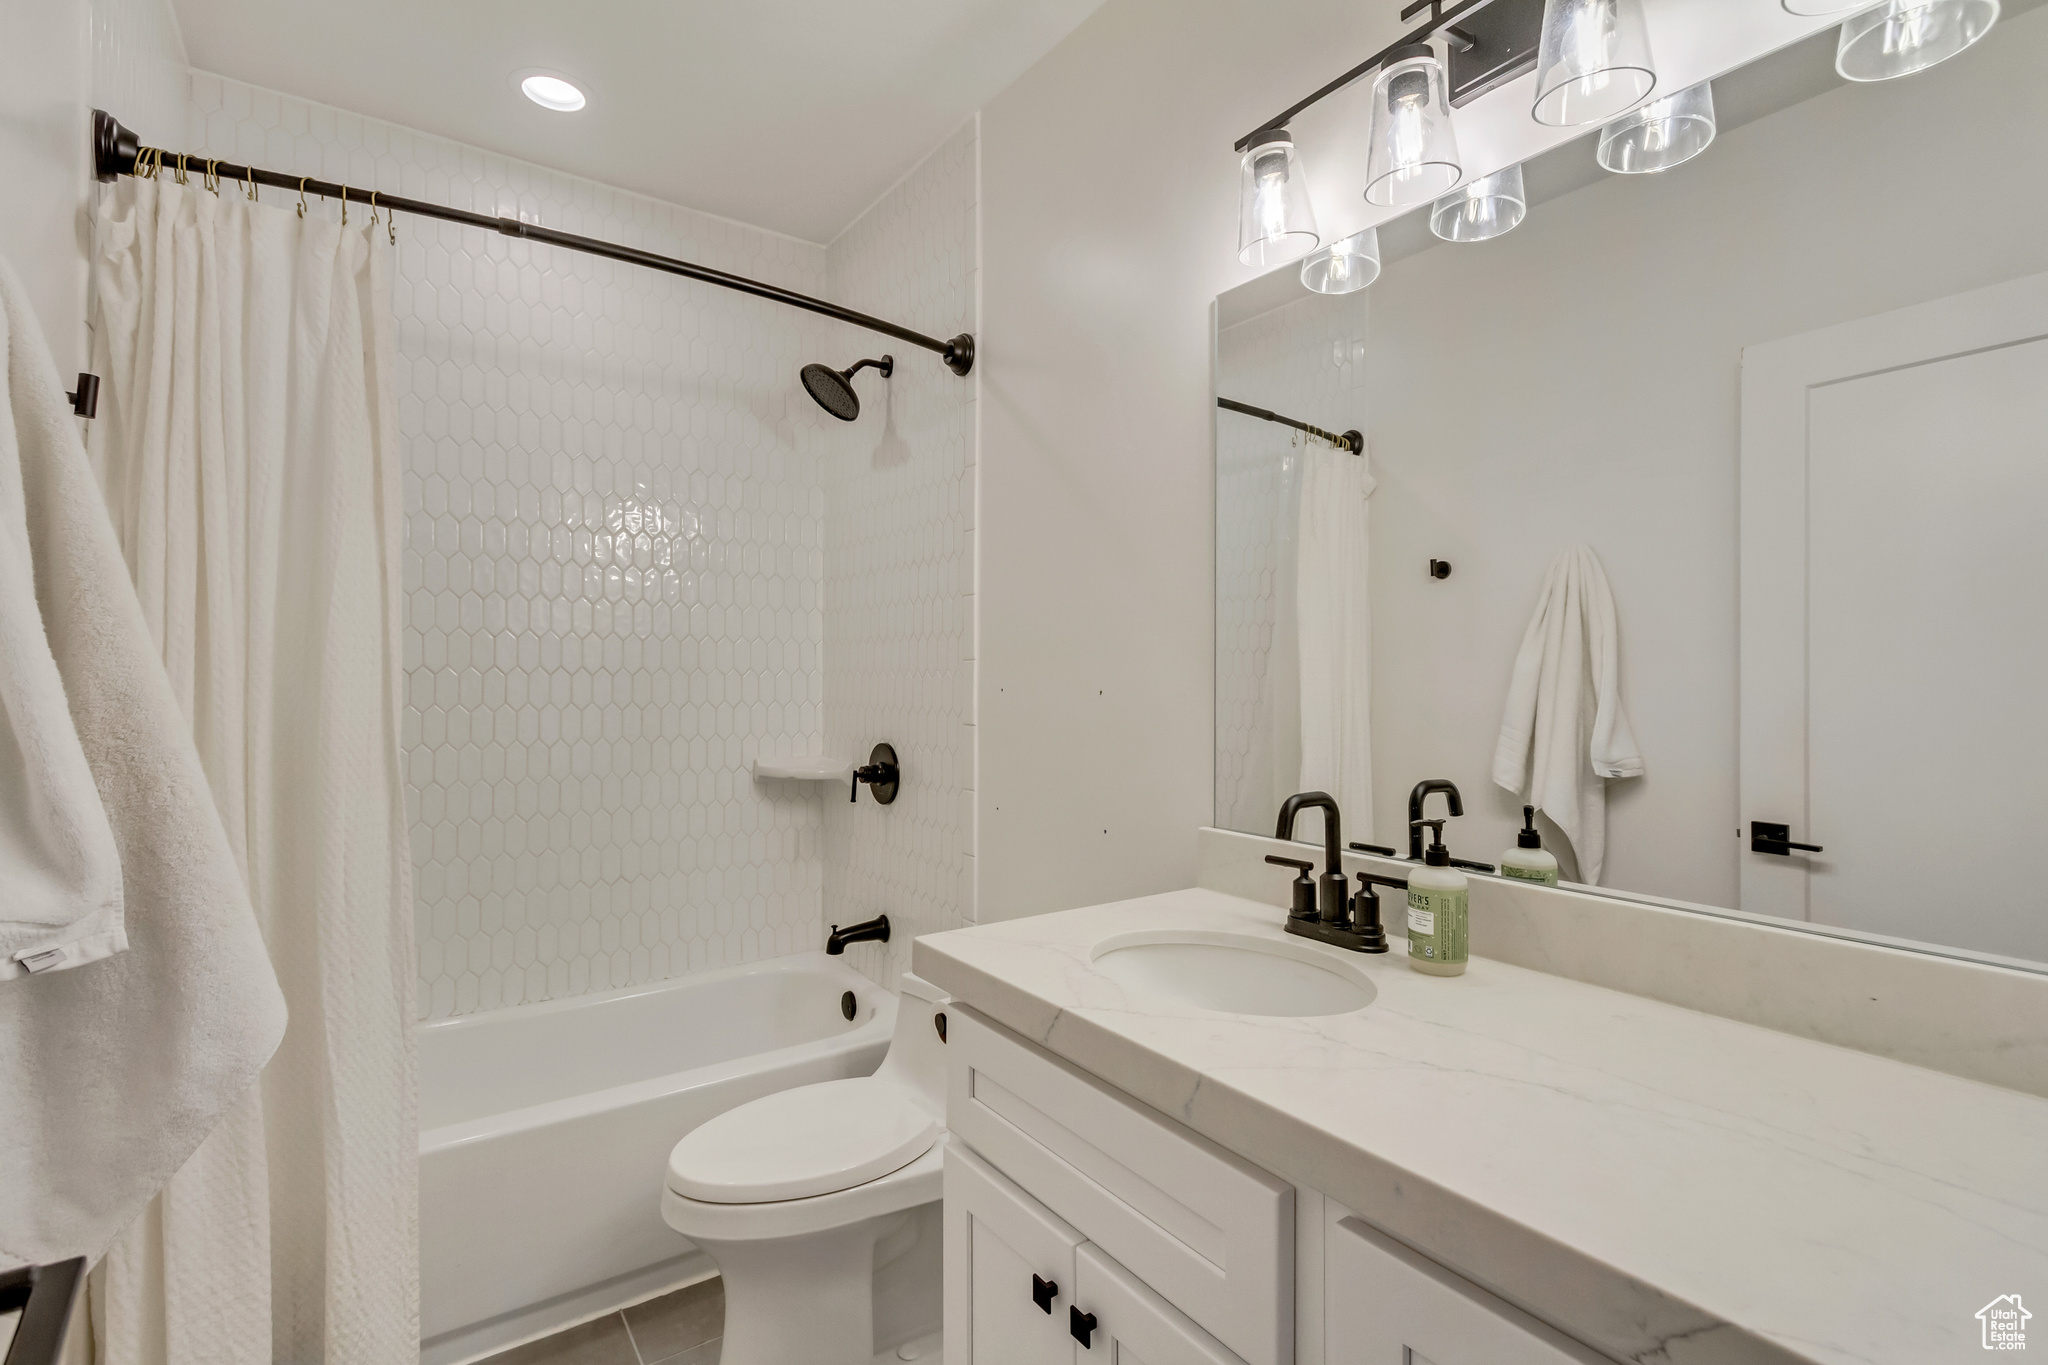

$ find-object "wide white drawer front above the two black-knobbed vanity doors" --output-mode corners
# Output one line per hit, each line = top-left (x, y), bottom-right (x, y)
(946, 1005), (1294, 1365)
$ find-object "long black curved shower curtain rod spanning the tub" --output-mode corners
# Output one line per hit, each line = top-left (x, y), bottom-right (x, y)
(92, 108), (975, 375)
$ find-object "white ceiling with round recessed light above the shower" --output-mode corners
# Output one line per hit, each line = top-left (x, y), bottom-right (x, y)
(174, 0), (1102, 241)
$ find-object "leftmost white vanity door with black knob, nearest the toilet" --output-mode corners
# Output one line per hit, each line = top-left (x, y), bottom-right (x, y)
(944, 1142), (1081, 1365)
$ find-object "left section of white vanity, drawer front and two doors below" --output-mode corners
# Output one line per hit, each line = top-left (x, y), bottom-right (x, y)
(946, 1005), (1294, 1365)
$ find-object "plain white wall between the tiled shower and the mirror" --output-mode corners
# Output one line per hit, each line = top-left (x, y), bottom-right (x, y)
(977, 0), (1399, 919)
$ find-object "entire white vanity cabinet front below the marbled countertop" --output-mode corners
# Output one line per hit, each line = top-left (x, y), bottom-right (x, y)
(946, 1003), (1606, 1365)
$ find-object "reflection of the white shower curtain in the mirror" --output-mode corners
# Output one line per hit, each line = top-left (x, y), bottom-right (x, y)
(1294, 448), (1376, 839)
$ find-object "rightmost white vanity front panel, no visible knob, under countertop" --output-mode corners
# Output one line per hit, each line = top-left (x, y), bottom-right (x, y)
(1323, 1218), (1606, 1365)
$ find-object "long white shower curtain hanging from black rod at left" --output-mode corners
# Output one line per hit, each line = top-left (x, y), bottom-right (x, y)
(92, 174), (420, 1365)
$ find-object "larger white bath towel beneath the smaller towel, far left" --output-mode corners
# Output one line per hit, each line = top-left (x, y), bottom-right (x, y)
(0, 248), (285, 1269)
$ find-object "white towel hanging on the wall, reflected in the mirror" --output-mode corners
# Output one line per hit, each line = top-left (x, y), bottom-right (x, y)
(1493, 544), (1642, 886)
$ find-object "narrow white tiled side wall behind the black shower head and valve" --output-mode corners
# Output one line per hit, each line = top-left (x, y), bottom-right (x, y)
(825, 123), (981, 986)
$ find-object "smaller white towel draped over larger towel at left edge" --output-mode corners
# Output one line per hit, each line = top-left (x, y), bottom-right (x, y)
(0, 304), (127, 982)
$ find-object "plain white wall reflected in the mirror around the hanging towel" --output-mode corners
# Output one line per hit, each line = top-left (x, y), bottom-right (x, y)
(1233, 10), (2048, 905)
